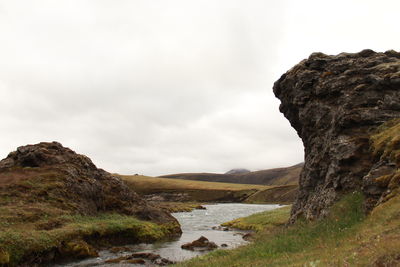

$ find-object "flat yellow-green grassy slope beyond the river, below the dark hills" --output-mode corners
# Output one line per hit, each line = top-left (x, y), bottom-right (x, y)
(119, 175), (297, 204)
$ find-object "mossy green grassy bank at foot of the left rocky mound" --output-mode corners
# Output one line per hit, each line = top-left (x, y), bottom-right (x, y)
(0, 214), (176, 266)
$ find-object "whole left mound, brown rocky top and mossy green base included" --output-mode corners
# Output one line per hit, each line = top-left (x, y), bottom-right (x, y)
(0, 142), (181, 266)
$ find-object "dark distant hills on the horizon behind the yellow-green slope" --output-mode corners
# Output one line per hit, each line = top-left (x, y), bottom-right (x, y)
(160, 163), (303, 185)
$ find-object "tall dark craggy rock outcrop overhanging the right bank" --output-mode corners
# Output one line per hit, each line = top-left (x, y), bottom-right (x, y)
(274, 50), (400, 222)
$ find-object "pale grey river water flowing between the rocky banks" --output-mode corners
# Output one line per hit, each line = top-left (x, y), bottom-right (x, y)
(61, 203), (280, 267)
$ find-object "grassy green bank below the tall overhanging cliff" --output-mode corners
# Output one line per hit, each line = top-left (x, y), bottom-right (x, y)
(176, 193), (400, 267)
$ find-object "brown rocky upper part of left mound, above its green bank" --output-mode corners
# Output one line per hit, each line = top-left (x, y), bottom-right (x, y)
(0, 142), (176, 226)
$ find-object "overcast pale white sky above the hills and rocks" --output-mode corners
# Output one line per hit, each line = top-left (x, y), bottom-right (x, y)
(0, 0), (400, 176)
